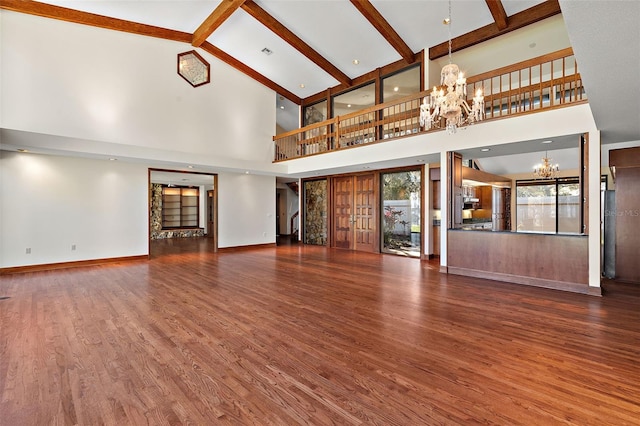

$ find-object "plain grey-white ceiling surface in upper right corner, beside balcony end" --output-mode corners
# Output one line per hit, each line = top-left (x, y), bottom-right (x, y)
(560, 0), (640, 143)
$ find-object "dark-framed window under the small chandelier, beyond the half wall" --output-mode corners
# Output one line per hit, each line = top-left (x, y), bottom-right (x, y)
(516, 178), (582, 234)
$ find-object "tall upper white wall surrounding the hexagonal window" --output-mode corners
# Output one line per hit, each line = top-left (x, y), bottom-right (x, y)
(0, 10), (276, 171)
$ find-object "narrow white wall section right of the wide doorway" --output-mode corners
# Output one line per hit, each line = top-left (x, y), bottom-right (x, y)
(218, 173), (276, 248)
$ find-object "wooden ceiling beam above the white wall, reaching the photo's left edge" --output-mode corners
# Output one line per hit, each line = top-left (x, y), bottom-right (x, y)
(0, 0), (191, 43)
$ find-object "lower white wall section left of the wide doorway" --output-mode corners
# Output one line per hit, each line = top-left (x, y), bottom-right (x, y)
(0, 151), (148, 267)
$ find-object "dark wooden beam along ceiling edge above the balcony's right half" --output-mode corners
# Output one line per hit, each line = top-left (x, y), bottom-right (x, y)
(429, 0), (561, 61)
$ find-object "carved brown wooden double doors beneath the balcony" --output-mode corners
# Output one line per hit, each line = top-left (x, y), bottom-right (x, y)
(331, 173), (380, 252)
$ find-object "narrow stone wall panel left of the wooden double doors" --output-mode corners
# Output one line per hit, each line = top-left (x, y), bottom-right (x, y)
(303, 179), (328, 246)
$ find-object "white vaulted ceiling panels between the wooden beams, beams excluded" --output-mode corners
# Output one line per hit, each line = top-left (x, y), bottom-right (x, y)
(35, 0), (544, 98)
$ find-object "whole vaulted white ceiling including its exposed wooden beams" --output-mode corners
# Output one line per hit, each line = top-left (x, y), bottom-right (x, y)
(1, 0), (560, 103)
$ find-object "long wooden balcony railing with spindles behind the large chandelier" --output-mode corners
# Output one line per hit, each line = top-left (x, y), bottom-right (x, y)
(273, 48), (587, 161)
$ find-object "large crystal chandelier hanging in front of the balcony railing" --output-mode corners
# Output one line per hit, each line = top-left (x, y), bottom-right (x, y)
(420, 0), (484, 134)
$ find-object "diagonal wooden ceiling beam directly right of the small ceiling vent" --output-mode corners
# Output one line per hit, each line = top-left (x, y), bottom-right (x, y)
(242, 0), (351, 85)
